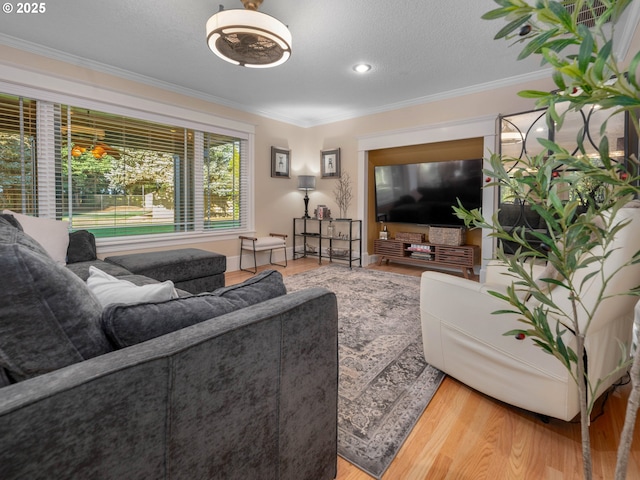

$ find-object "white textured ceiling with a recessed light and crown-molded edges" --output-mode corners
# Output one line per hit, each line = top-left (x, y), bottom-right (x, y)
(0, 0), (638, 126)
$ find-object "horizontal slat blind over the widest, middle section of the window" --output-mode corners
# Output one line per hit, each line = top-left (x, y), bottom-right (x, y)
(60, 106), (195, 237)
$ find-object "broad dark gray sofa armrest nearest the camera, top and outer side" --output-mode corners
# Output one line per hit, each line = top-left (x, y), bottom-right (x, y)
(0, 288), (338, 480)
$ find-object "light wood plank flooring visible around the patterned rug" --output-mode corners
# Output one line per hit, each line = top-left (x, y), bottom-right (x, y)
(227, 259), (640, 480)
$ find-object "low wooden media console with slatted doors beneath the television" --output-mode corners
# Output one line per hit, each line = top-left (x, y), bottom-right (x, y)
(373, 240), (480, 278)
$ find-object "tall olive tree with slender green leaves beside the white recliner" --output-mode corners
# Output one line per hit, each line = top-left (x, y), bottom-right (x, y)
(455, 0), (640, 479)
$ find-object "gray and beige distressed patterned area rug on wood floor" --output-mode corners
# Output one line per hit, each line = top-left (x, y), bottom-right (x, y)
(285, 265), (444, 479)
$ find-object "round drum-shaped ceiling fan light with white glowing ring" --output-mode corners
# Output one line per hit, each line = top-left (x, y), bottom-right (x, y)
(207, 0), (291, 68)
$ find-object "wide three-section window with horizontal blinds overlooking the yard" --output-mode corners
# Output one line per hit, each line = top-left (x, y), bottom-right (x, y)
(0, 91), (248, 237)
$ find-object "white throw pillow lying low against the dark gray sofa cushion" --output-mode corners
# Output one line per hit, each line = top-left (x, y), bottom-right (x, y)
(87, 266), (178, 307)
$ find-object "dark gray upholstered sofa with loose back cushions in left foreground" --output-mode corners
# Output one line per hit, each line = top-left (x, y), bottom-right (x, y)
(0, 218), (338, 480)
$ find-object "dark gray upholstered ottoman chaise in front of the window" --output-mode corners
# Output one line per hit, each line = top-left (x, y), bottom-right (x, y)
(105, 248), (227, 293)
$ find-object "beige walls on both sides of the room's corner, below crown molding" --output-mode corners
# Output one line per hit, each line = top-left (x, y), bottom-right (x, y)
(0, 29), (640, 270)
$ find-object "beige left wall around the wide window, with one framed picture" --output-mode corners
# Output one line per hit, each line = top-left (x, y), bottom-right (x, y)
(0, 45), (310, 257)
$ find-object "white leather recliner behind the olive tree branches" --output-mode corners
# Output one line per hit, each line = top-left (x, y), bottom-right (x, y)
(420, 208), (640, 421)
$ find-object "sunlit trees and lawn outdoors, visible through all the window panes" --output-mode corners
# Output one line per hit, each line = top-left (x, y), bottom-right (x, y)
(0, 133), (240, 235)
